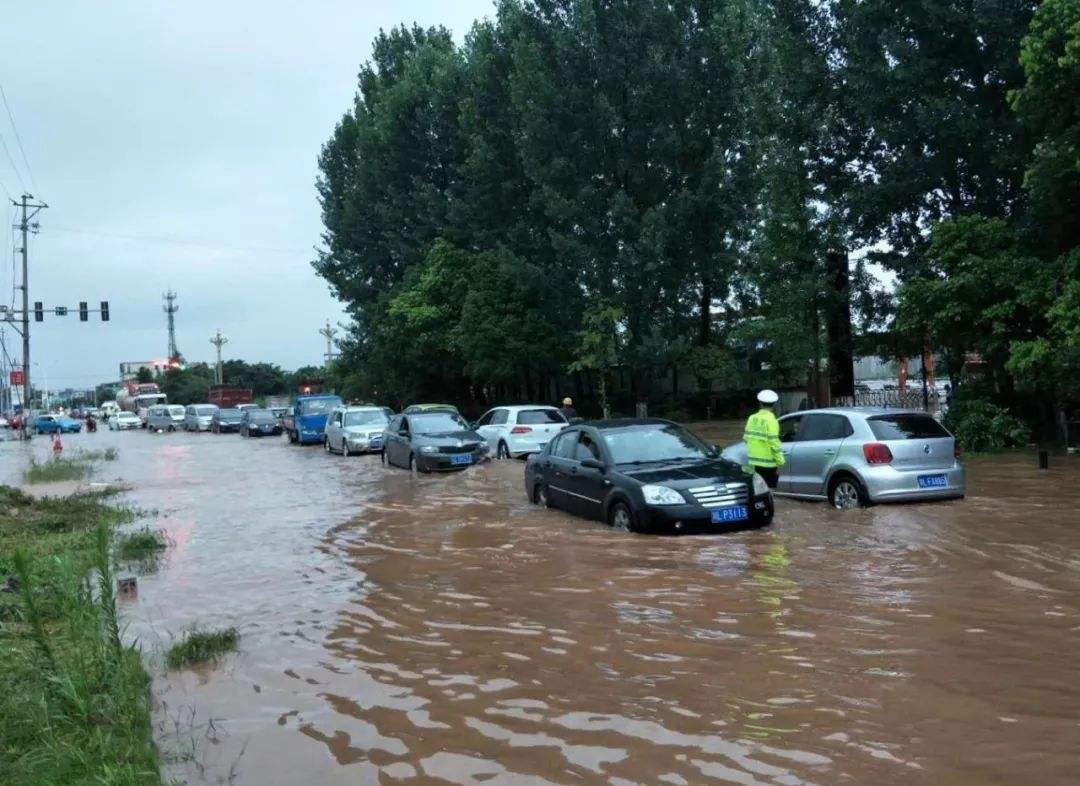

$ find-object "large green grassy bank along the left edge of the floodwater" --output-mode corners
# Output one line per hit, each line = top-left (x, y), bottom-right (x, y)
(0, 486), (161, 786)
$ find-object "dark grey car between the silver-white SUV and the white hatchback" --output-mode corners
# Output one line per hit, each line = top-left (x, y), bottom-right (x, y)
(382, 411), (487, 472)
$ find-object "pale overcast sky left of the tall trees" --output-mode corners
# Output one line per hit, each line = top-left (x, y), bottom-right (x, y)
(0, 0), (492, 390)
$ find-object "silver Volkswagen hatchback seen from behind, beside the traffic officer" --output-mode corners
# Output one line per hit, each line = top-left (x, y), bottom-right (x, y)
(724, 407), (964, 509)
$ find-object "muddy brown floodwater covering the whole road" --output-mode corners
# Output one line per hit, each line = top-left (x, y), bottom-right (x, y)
(3, 432), (1080, 786)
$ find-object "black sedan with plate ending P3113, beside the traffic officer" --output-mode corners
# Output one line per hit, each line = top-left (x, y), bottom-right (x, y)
(525, 419), (772, 532)
